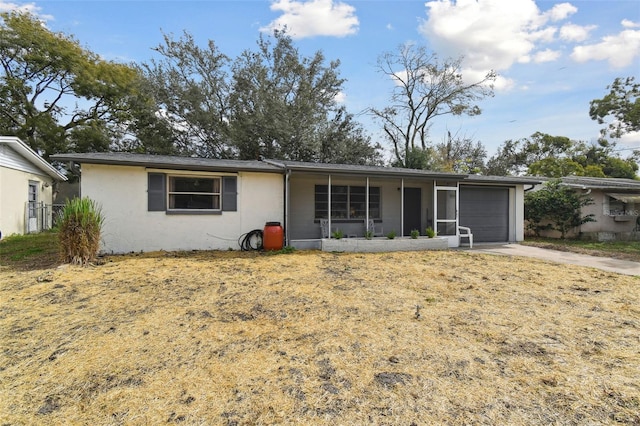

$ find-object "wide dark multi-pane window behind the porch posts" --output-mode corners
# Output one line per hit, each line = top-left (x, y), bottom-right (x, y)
(315, 185), (380, 219)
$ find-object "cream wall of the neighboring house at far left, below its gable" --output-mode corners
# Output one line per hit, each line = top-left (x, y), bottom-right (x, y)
(0, 167), (53, 237)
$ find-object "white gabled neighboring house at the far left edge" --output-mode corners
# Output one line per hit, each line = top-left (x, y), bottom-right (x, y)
(0, 136), (67, 236)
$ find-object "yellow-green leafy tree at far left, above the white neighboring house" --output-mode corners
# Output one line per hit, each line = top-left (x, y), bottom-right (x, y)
(0, 12), (139, 158)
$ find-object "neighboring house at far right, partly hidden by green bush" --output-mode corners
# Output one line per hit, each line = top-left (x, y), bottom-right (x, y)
(541, 176), (640, 241)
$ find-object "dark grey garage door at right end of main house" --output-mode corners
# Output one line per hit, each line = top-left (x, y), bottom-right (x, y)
(459, 185), (509, 242)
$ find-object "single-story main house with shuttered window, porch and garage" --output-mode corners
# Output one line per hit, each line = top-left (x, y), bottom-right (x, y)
(48, 153), (540, 253)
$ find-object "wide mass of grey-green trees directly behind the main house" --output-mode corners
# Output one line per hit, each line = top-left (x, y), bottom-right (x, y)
(143, 31), (381, 164)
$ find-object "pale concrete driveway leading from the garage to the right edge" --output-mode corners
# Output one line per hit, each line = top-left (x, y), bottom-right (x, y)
(472, 244), (640, 275)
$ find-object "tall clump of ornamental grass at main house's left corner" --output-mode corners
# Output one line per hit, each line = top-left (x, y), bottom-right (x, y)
(58, 197), (104, 265)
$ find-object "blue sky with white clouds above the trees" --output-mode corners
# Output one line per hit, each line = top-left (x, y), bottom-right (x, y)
(0, 0), (640, 157)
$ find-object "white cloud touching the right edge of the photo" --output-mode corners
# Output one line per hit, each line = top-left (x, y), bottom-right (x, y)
(571, 30), (640, 68)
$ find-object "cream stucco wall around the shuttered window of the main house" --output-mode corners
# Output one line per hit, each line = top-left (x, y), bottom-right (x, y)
(81, 164), (284, 253)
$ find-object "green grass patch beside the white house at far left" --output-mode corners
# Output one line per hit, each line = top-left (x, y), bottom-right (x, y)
(0, 232), (59, 270)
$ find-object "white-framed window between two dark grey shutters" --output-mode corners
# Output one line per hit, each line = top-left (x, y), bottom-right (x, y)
(168, 176), (221, 210)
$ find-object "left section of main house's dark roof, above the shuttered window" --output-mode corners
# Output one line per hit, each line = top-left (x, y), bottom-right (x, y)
(51, 152), (282, 173)
